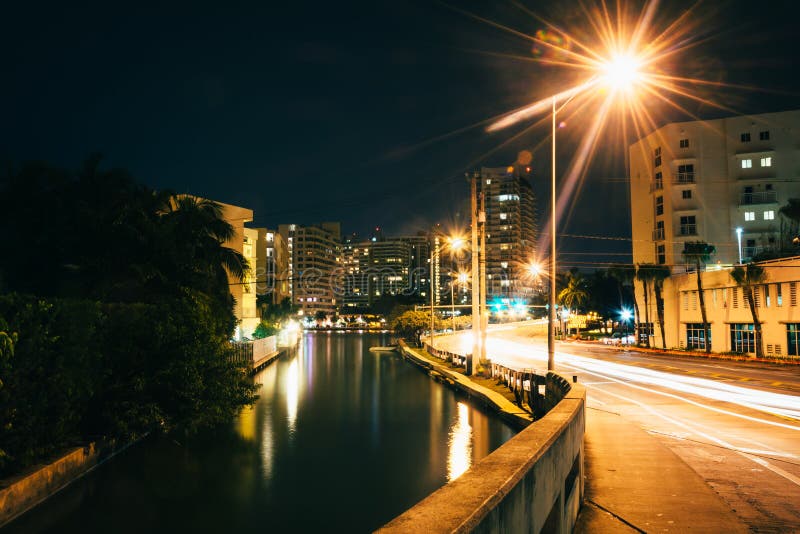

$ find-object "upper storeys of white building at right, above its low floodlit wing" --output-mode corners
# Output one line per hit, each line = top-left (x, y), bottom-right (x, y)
(630, 110), (800, 272)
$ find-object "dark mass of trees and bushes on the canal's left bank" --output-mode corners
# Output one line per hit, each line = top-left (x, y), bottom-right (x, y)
(0, 159), (254, 476)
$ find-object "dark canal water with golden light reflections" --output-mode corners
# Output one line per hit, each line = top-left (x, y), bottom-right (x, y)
(3, 333), (514, 534)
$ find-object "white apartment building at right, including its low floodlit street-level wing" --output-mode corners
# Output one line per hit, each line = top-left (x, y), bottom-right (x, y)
(630, 110), (800, 356)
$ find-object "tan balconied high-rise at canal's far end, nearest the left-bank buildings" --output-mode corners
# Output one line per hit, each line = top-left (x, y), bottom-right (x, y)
(278, 222), (342, 316)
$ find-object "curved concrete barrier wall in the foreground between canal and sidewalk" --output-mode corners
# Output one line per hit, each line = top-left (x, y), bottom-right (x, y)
(378, 373), (586, 534)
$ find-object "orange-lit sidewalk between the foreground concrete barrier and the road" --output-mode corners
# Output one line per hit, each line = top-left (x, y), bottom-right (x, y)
(575, 409), (748, 533)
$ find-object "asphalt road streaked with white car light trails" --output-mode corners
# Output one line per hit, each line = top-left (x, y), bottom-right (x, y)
(436, 327), (800, 532)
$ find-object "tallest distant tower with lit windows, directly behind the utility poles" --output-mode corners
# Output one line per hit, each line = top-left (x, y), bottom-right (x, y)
(478, 166), (536, 300)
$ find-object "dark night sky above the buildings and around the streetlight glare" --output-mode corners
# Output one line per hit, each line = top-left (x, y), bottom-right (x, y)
(0, 0), (800, 265)
